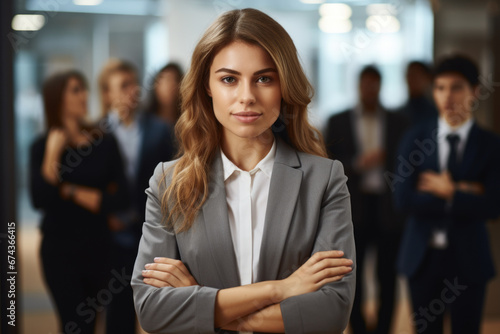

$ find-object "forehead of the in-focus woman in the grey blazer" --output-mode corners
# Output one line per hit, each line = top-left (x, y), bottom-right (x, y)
(211, 41), (276, 70)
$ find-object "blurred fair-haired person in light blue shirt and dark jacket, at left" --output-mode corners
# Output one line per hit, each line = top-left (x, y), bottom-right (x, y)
(99, 59), (175, 334)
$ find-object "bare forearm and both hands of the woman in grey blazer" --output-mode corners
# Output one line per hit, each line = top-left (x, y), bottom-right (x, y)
(142, 251), (352, 333)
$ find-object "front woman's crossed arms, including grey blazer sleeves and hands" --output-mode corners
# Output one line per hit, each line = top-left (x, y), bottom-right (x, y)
(132, 163), (355, 333)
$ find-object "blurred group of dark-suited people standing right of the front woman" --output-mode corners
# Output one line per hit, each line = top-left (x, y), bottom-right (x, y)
(325, 55), (500, 334)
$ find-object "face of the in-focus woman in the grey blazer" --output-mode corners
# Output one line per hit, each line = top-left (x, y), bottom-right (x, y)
(208, 41), (281, 140)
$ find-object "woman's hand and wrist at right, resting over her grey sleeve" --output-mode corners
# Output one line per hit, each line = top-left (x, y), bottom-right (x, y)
(278, 251), (353, 300)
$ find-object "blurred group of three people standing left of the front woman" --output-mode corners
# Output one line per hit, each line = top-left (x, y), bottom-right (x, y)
(30, 59), (183, 334)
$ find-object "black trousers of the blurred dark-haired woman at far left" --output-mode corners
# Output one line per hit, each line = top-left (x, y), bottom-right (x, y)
(40, 237), (109, 334)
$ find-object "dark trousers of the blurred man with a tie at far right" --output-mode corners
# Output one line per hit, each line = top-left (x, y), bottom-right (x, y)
(408, 249), (486, 334)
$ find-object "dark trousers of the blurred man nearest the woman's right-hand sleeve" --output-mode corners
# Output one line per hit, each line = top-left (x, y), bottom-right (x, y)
(350, 195), (401, 334)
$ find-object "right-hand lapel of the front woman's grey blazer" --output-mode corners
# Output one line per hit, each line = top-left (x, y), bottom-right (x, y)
(257, 137), (302, 281)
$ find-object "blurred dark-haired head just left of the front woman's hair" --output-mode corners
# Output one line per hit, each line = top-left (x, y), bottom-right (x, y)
(146, 63), (184, 127)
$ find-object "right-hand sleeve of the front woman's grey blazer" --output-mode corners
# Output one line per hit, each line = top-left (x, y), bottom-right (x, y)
(280, 161), (356, 334)
